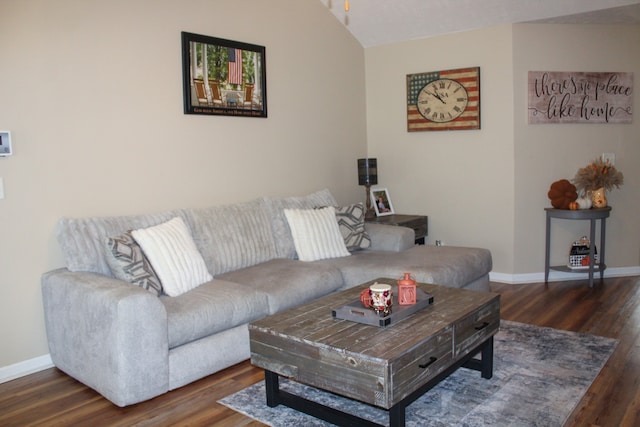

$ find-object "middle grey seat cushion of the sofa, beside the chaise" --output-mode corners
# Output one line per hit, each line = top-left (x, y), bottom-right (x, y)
(218, 258), (344, 314)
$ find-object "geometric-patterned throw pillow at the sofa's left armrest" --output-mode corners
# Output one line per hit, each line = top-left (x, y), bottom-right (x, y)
(105, 231), (163, 296)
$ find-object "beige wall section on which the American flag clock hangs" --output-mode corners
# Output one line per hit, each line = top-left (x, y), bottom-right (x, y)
(365, 26), (514, 272)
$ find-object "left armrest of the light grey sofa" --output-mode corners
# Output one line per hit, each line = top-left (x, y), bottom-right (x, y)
(41, 269), (169, 406)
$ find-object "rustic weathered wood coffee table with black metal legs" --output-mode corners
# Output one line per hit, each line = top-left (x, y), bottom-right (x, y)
(249, 279), (500, 426)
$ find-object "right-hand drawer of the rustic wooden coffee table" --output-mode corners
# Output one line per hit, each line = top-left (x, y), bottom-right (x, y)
(453, 299), (500, 358)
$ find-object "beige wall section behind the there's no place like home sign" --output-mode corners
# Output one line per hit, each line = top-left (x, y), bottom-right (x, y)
(513, 24), (640, 273)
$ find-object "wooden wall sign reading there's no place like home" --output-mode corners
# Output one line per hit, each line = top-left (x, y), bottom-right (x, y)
(528, 71), (633, 124)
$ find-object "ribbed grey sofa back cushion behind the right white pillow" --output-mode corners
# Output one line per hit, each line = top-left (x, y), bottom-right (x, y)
(263, 189), (337, 259)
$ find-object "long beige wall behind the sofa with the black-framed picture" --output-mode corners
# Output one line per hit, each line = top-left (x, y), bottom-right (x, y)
(0, 0), (366, 368)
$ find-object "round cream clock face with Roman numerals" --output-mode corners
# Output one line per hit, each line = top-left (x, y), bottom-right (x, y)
(416, 79), (469, 123)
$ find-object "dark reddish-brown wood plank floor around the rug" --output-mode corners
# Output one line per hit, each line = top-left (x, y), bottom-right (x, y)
(0, 277), (640, 427)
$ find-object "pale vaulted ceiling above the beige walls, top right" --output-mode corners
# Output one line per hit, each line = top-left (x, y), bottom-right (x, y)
(320, 0), (640, 48)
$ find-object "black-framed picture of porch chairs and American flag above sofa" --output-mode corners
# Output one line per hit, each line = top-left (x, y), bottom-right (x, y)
(182, 32), (267, 117)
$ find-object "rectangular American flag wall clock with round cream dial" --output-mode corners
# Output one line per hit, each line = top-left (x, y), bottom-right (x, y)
(407, 67), (480, 132)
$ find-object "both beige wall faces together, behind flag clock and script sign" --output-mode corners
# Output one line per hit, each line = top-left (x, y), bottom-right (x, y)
(365, 24), (640, 282)
